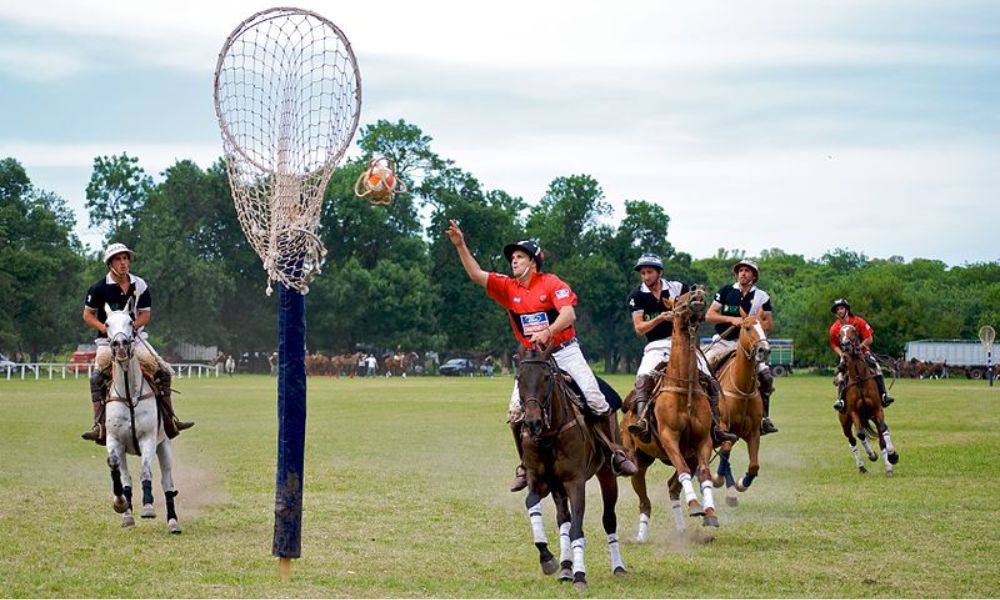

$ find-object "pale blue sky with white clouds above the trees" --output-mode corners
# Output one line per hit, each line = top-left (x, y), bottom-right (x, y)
(0, 0), (1000, 265)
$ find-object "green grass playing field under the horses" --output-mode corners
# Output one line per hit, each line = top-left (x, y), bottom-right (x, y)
(0, 376), (1000, 597)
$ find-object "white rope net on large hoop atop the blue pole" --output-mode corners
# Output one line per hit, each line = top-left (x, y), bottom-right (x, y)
(215, 8), (361, 294)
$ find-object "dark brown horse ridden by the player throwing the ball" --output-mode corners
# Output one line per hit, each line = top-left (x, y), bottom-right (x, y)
(517, 346), (626, 592)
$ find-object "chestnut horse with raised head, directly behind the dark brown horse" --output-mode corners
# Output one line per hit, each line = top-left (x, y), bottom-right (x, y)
(621, 286), (720, 542)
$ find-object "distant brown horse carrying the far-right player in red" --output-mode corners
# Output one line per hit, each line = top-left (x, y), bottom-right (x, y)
(839, 325), (899, 476)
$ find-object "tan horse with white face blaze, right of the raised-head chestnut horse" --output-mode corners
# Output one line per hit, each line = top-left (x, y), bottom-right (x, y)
(715, 309), (771, 506)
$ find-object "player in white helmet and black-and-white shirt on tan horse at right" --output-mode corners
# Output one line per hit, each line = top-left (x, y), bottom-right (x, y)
(705, 259), (778, 435)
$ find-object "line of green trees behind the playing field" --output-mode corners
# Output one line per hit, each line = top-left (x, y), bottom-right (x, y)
(0, 120), (1000, 372)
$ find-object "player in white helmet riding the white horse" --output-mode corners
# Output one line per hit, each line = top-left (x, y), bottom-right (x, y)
(81, 243), (194, 446)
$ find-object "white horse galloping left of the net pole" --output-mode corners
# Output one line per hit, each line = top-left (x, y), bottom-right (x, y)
(104, 300), (181, 533)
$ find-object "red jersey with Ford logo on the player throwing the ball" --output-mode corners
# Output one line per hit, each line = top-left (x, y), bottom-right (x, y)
(486, 273), (576, 348)
